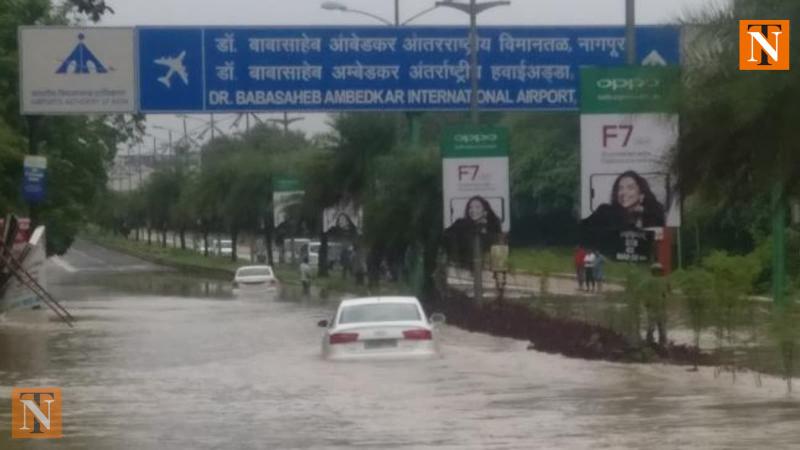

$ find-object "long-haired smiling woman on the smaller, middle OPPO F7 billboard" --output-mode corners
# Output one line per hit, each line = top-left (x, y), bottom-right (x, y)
(444, 195), (502, 266)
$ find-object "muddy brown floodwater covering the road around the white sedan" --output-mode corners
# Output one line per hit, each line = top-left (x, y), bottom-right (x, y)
(0, 239), (800, 449)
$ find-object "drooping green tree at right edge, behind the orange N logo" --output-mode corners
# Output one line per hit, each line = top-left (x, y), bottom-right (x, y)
(673, 0), (800, 208)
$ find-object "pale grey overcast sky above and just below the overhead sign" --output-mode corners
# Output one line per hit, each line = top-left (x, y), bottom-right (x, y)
(101, 0), (726, 142)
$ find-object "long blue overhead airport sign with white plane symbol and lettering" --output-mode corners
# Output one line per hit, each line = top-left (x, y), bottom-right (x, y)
(138, 26), (680, 112)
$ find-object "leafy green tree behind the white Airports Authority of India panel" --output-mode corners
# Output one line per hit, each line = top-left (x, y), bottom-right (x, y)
(0, 0), (140, 253)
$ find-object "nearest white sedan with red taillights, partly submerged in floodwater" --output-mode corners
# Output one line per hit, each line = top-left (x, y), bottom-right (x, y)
(318, 297), (444, 359)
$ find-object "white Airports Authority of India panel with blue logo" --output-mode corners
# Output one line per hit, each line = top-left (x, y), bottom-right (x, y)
(19, 27), (137, 114)
